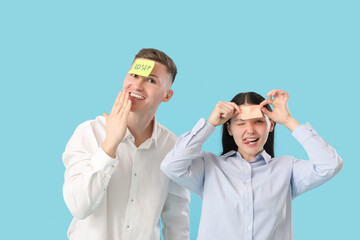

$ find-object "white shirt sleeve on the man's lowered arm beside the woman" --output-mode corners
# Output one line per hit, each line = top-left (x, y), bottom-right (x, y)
(161, 181), (190, 240)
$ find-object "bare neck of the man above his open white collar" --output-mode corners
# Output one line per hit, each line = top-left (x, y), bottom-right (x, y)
(128, 112), (155, 147)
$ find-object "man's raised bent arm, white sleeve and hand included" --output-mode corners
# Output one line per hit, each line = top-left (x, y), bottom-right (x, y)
(63, 92), (131, 219)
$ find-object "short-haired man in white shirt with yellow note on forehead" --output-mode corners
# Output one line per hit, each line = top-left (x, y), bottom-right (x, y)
(63, 49), (190, 240)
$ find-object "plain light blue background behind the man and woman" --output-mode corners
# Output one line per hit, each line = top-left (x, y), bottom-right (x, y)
(0, 0), (360, 240)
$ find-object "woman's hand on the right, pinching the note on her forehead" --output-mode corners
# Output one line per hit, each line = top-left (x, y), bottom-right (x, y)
(260, 89), (300, 131)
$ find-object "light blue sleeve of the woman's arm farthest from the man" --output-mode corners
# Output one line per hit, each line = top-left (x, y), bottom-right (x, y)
(291, 123), (343, 198)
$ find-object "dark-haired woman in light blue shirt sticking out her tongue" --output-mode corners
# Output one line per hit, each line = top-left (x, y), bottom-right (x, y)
(161, 90), (342, 240)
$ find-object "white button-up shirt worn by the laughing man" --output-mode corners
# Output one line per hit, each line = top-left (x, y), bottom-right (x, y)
(63, 116), (190, 240)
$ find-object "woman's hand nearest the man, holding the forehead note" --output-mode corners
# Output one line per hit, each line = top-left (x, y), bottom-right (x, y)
(208, 102), (240, 127)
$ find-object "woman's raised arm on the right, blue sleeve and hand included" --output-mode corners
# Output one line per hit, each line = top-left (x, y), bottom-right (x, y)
(260, 90), (343, 197)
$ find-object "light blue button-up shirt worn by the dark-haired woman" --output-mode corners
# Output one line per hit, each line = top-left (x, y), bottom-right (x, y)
(161, 119), (342, 240)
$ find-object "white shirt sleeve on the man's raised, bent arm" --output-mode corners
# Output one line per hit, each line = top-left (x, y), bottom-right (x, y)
(63, 122), (118, 219)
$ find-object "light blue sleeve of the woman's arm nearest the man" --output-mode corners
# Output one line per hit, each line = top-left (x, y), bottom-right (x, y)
(161, 118), (215, 197)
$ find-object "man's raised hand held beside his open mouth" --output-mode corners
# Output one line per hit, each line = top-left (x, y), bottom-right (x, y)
(101, 91), (131, 158)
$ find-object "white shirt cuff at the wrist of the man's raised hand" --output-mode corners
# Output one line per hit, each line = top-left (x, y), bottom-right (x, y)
(91, 147), (119, 175)
